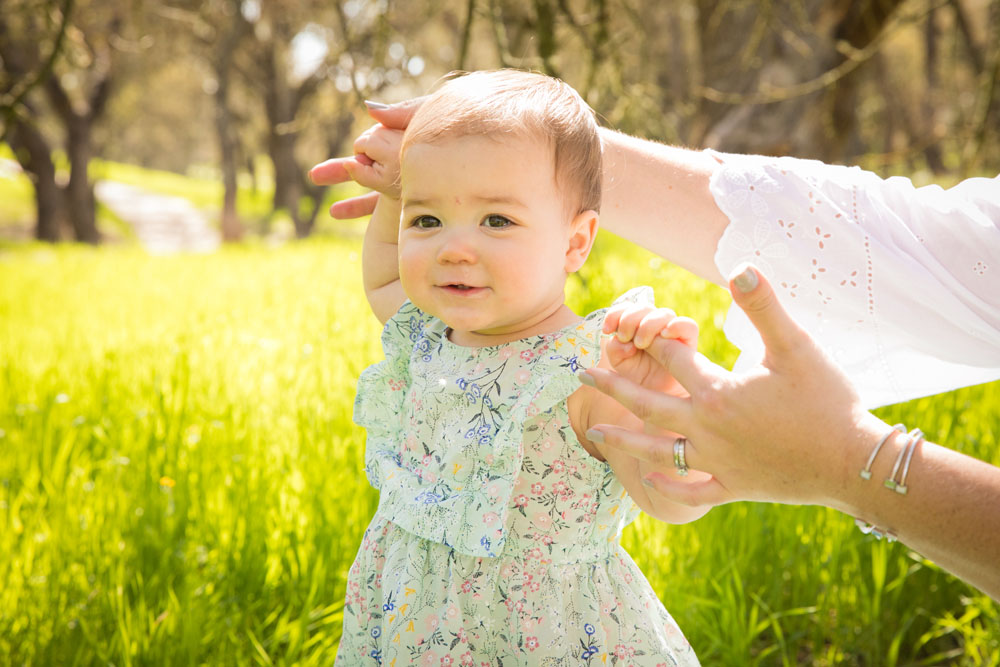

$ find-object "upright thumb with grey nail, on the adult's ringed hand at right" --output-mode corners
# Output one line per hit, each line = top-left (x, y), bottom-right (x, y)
(729, 264), (807, 354)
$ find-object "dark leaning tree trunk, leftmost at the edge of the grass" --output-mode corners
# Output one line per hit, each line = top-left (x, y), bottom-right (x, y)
(9, 122), (68, 243)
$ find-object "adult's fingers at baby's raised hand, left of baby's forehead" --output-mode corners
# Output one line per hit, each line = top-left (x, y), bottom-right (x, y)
(309, 97), (424, 220)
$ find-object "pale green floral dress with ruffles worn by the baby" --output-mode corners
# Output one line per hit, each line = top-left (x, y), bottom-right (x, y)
(337, 288), (698, 667)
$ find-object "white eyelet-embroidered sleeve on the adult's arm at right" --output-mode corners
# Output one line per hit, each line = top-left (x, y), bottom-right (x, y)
(710, 153), (1000, 407)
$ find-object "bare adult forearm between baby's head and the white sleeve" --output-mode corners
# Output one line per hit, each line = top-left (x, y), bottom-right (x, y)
(601, 129), (729, 284)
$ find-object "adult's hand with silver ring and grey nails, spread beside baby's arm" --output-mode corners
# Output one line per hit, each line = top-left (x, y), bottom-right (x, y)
(587, 266), (888, 506)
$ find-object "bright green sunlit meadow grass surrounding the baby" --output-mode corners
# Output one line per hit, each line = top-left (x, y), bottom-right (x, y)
(0, 243), (1000, 665)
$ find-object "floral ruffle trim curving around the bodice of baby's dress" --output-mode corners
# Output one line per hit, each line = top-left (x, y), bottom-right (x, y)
(354, 287), (653, 557)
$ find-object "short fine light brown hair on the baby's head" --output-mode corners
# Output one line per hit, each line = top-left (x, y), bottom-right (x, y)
(401, 69), (601, 213)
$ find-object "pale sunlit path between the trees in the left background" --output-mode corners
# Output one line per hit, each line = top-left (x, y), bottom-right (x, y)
(94, 181), (220, 255)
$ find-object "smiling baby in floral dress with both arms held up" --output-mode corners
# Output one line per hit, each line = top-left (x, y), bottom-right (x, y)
(338, 70), (705, 666)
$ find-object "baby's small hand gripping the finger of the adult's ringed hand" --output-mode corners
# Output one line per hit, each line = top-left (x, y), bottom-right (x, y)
(603, 303), (698, 396)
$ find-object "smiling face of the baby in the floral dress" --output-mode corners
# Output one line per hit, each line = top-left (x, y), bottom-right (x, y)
(399, 136), (573, 345)
